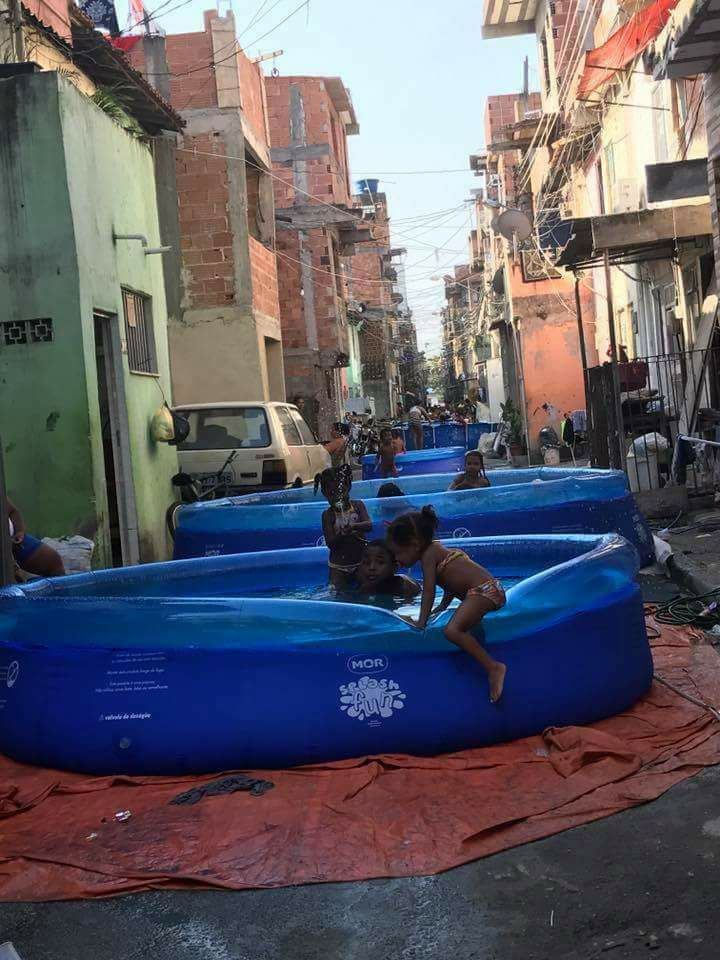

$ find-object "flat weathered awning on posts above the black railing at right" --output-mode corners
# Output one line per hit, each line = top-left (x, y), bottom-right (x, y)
(555, 203), (712, 270)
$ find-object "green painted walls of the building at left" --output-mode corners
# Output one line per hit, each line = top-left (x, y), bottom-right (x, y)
(0, 72), (177, 565)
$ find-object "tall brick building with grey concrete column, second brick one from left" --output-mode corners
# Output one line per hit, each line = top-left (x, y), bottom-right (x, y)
(265, 77), (367, 437)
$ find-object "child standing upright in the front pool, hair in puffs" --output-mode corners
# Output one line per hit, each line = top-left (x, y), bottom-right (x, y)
(315, 464), (372, 589)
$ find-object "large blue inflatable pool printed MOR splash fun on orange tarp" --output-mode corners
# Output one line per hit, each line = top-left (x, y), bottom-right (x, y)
(0, 536), (652, 775)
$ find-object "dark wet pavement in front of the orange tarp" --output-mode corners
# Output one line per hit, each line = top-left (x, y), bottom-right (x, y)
(0, 768), (720, 960)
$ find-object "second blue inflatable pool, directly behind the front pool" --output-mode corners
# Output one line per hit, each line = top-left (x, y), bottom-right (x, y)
(175, 464), (654, 564)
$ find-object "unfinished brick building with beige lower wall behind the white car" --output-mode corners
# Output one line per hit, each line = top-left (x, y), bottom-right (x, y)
(128, 11), (285, 403)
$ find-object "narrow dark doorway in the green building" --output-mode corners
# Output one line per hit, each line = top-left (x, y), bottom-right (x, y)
(93, 313), (139, 567)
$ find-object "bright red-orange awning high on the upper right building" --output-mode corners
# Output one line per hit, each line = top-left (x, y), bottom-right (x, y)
(577, 0), (678, 100)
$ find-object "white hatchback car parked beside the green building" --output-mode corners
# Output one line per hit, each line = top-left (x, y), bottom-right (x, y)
(174, 401), (330, 493)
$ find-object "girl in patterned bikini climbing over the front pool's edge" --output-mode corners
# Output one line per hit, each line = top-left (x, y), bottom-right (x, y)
(387, 506), (506, 703)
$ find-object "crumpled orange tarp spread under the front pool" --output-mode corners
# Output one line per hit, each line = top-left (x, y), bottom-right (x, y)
(0, 620), (720, 900)
